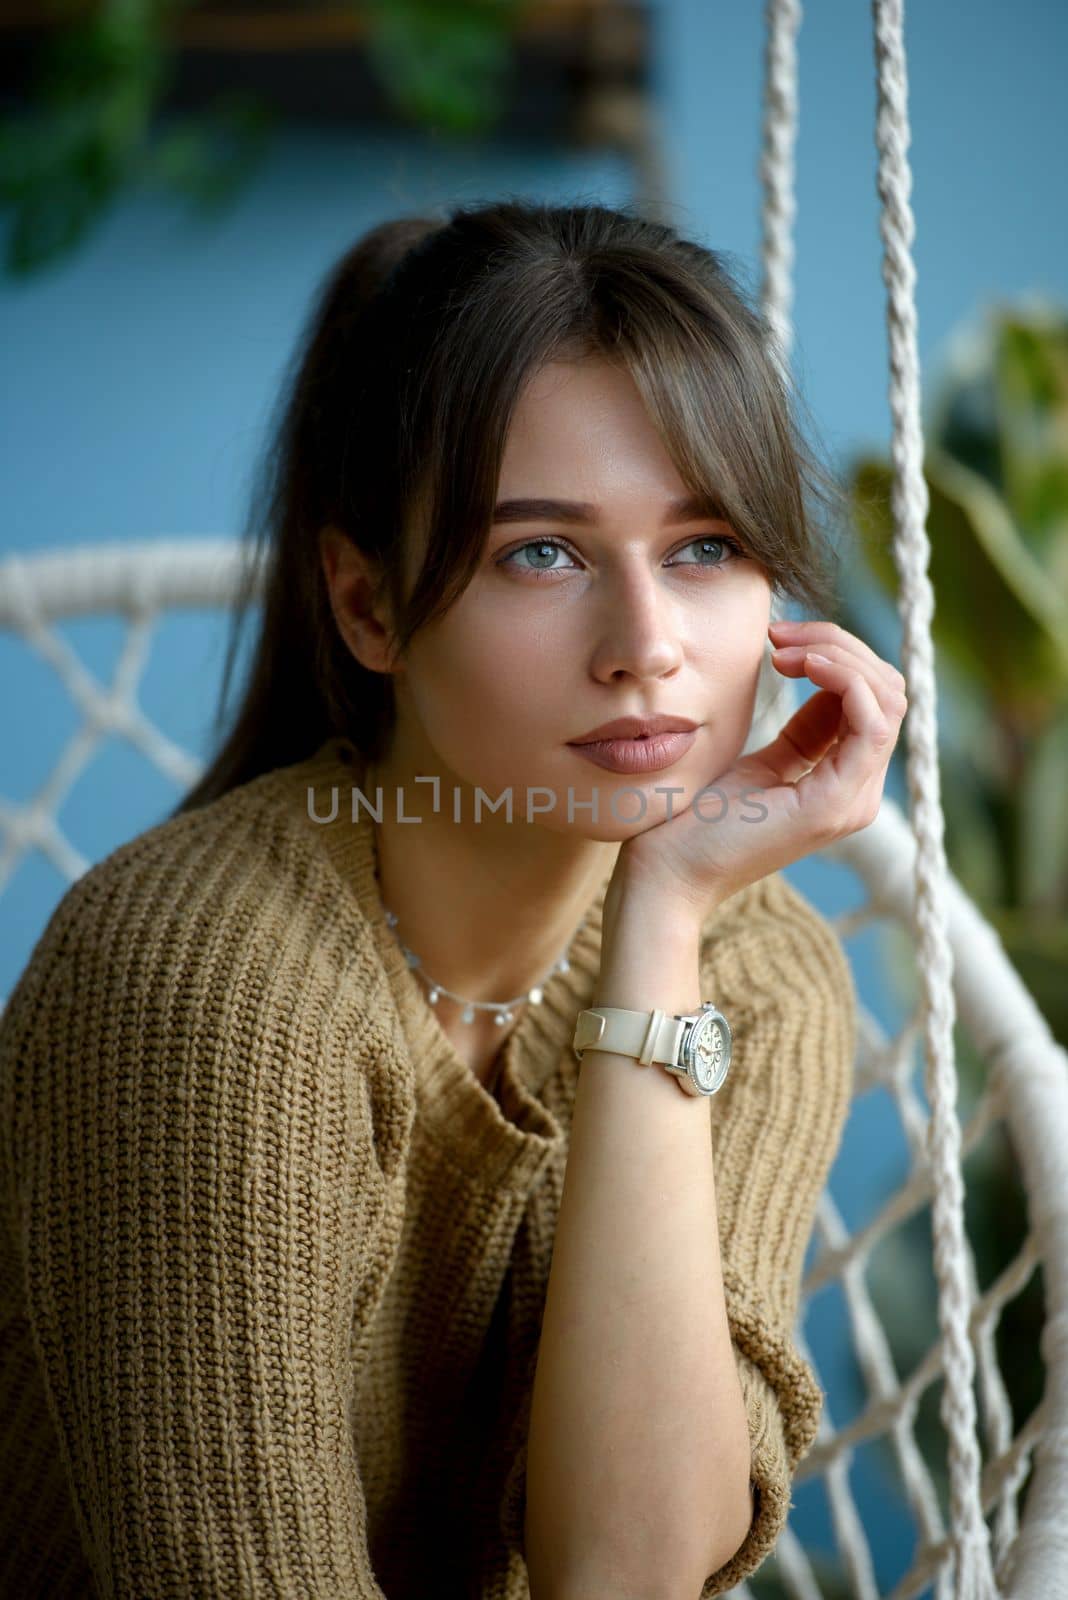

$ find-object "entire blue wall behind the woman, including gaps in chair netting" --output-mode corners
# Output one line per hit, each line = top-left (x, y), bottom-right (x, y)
(0, 0), (1068, 1587)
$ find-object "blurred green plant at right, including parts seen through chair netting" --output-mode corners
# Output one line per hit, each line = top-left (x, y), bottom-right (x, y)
(843, 304), (1068, 1548)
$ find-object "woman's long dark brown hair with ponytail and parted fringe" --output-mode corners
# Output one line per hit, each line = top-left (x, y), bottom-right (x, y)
(173, 198), (844, 814)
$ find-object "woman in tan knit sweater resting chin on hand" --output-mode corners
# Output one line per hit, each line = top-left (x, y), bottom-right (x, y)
(0, 202), (905, 1600)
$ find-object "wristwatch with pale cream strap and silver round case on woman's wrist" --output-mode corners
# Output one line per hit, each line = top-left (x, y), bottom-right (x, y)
(571, 1000), (731, 1094)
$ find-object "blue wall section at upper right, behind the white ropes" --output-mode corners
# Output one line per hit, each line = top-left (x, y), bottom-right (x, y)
(659, 0), (1068, 454)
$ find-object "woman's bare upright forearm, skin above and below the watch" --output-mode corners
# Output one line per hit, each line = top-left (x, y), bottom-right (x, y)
(524, 883), (751, 1600)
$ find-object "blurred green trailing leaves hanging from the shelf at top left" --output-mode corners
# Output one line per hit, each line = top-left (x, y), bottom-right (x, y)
(0, 0), (521, 277)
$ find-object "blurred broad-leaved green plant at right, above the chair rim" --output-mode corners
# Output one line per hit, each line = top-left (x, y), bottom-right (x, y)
(851, 307), (1068, 1043)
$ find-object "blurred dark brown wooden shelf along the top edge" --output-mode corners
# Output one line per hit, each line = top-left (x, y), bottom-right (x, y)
(0, 0), (651, 144)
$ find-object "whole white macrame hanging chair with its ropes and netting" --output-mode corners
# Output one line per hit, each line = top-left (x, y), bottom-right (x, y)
(0, 0), (1068, 1600)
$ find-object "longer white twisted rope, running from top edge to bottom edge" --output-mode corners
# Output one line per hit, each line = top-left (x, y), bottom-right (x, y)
(873, 0), (998, 1600)
